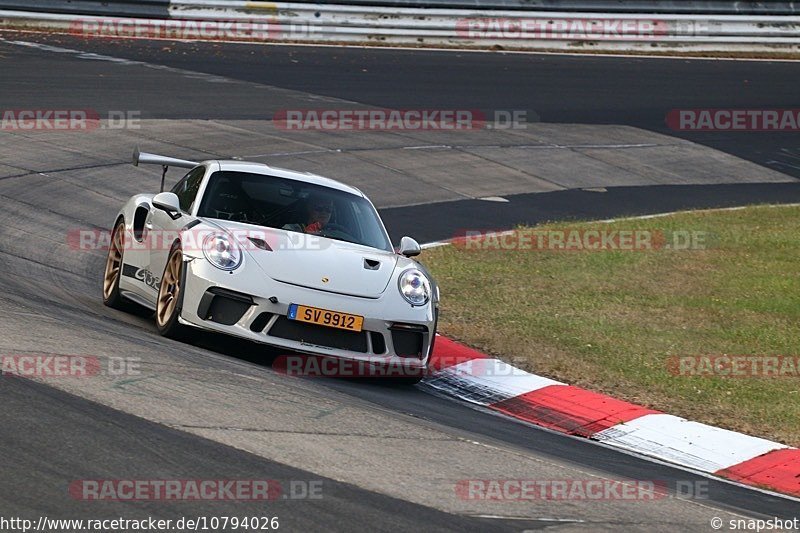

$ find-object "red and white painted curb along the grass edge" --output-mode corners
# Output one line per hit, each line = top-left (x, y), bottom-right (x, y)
(423, 336), (800, 497)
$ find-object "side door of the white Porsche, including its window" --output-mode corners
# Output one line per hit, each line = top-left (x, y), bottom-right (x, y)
(146, 166), (206, 302)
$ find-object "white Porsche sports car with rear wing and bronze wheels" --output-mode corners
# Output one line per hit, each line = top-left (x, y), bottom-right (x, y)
(103, 149), (439, 371)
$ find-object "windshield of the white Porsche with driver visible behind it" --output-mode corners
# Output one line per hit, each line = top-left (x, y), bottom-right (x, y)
(197, 171), (392, 251)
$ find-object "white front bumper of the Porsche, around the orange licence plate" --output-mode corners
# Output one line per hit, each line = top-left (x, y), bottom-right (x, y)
(180, 258), (436, 369)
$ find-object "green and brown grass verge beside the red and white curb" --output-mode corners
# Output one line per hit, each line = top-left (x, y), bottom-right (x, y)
(423, 206), (800, 446)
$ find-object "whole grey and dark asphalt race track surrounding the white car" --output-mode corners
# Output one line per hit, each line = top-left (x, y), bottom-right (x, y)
(0, 34), (800, 531)
